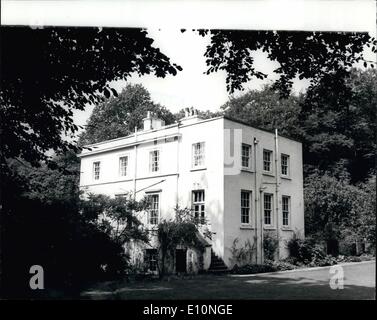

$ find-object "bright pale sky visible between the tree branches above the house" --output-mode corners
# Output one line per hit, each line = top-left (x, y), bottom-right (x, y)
(74, 28), (307, 129)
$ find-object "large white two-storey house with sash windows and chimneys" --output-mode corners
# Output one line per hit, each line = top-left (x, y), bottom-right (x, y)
(79, 110), (304, 271)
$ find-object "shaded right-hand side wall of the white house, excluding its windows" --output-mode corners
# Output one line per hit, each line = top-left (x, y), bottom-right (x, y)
(224, 119), (304, 266)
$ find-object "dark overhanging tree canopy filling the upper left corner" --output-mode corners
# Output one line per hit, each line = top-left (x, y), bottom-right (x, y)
(0, 27), (181, 168)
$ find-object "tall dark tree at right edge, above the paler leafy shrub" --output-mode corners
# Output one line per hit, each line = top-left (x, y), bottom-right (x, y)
(300, 69), (377, 183)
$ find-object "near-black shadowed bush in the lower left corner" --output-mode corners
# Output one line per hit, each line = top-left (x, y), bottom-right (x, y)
(1, 174), (127, 298)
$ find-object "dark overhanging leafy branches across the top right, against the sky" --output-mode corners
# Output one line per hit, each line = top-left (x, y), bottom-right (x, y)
(198, 30), (377, 97)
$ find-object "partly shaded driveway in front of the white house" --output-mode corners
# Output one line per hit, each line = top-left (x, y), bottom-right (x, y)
(82, 261), (376, 300)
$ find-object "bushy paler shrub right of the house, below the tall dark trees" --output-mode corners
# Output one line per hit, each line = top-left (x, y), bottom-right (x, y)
(304, 171), (376, 248)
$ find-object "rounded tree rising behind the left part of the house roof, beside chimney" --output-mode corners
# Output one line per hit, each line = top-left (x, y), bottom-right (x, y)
(80, 84), (175, 145)
